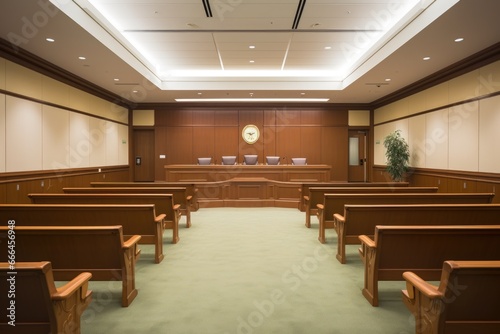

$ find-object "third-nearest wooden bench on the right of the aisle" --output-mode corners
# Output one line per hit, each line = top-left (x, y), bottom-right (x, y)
(334, 204), (500, 263)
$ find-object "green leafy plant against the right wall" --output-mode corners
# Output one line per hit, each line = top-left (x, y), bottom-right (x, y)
(384, 130), (410, 182)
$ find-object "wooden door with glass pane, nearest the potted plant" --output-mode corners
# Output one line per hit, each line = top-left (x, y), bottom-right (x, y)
(348, 130), (367, 182)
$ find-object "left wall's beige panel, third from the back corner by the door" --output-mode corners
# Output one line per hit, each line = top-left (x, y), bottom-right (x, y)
(69, 112), (91, 168)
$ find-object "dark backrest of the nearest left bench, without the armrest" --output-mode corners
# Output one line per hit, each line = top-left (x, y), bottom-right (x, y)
(0, 262), (56, 333)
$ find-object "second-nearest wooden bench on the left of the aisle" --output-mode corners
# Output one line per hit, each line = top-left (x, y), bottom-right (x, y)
(0, 226), (141, 306)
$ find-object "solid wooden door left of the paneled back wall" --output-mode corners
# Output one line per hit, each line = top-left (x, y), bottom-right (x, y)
(133, 129), (155, 182)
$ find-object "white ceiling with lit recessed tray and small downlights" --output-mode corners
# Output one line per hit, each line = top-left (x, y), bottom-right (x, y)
(0, 0), (500, 103)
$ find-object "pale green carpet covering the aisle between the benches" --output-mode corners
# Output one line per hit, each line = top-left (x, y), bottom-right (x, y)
(82, 208), (415, 334)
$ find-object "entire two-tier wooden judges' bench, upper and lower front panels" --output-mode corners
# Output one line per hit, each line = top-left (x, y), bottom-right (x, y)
(165, 165), (331, 208)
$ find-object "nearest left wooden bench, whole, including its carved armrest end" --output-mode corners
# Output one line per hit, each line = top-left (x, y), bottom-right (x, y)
(0, 261), (92, 334)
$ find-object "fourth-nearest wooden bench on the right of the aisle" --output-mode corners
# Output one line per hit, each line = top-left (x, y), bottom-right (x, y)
(317, 193), (495, 243)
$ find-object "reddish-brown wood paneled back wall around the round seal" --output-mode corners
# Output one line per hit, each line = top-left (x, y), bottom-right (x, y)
(155, 106), (348, 181)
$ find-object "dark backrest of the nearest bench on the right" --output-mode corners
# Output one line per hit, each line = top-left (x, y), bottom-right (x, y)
(438, 261), (500, 333)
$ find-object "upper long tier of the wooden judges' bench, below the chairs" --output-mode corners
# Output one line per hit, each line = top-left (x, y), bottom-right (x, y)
(165, 165), (332, 182)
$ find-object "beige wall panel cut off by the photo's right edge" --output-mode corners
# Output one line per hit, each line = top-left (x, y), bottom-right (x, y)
(479, 96), (500, 173)
